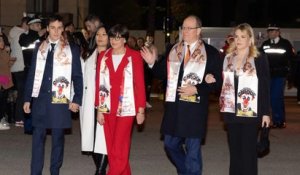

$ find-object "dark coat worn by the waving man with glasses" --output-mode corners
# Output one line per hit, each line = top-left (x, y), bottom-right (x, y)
(152, 43), (222, 138)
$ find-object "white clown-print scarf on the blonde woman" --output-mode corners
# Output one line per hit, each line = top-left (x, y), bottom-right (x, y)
(220, 54), (258, 117)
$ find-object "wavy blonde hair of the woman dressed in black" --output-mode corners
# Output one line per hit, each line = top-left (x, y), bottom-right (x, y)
(226, 23), (259, 58)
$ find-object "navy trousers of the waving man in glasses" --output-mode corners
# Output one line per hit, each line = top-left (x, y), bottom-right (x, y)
(164, 135), (202, 175)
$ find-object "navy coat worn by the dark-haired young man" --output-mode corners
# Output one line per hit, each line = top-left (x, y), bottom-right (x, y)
(24, 43), (83, 128)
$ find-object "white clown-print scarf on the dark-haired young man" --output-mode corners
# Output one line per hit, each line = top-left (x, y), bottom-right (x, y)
(32, 40), (72, 104)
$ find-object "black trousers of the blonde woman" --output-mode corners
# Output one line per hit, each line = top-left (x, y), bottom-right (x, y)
(227, 123), (258, 175)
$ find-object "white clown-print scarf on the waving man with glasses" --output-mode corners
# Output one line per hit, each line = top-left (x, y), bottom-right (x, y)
(166, 40), (207, 103)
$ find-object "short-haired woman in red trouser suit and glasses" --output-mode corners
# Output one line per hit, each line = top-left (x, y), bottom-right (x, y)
(95, 24), (146, 175)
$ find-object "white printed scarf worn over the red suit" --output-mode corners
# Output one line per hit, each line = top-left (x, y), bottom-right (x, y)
(98, 50), (136, 117)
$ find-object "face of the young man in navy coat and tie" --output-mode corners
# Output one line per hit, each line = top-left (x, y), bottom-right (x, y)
(47, 20), (64, 41)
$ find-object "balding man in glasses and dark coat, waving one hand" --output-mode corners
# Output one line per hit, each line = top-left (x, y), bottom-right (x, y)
(142, 16), (222, 175)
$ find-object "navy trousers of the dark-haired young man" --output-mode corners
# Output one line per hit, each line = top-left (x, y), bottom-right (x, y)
(31, 127), (65, 175)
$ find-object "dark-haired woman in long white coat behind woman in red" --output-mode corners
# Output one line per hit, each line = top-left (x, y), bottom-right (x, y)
(80, 26), (109, 175)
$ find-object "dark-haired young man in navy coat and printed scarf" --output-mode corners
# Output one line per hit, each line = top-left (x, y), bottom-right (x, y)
(23, 15), (83, 175)
